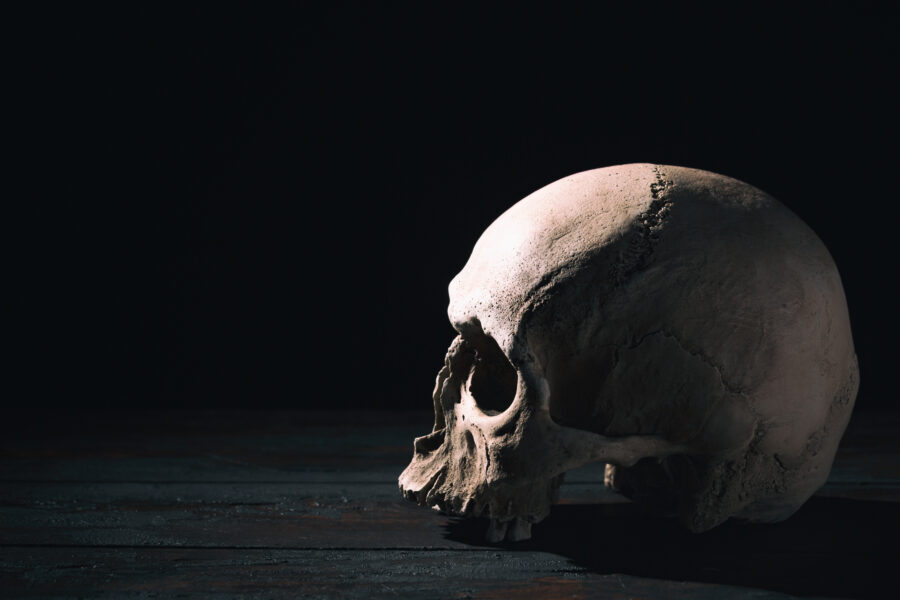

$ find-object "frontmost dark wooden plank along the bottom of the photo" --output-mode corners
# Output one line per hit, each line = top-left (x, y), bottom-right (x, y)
(0, 544), (856, 600)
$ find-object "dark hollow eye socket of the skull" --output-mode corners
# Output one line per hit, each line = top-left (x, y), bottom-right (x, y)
(466, 334), (518, 415)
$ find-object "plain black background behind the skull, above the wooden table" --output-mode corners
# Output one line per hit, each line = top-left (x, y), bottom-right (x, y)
(6, 3), (898, 409)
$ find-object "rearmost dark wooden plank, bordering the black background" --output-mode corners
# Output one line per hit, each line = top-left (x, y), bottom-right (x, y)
(0, 411), (900, 487)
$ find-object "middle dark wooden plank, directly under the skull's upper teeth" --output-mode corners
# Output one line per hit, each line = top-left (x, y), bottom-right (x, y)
(0, 483), (900, 554)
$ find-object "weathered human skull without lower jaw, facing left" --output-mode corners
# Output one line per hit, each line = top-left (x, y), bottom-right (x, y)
(400, 164), (858, 541)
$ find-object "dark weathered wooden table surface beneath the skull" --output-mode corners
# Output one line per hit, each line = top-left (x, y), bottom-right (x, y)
(0, 411), (900, 599)
